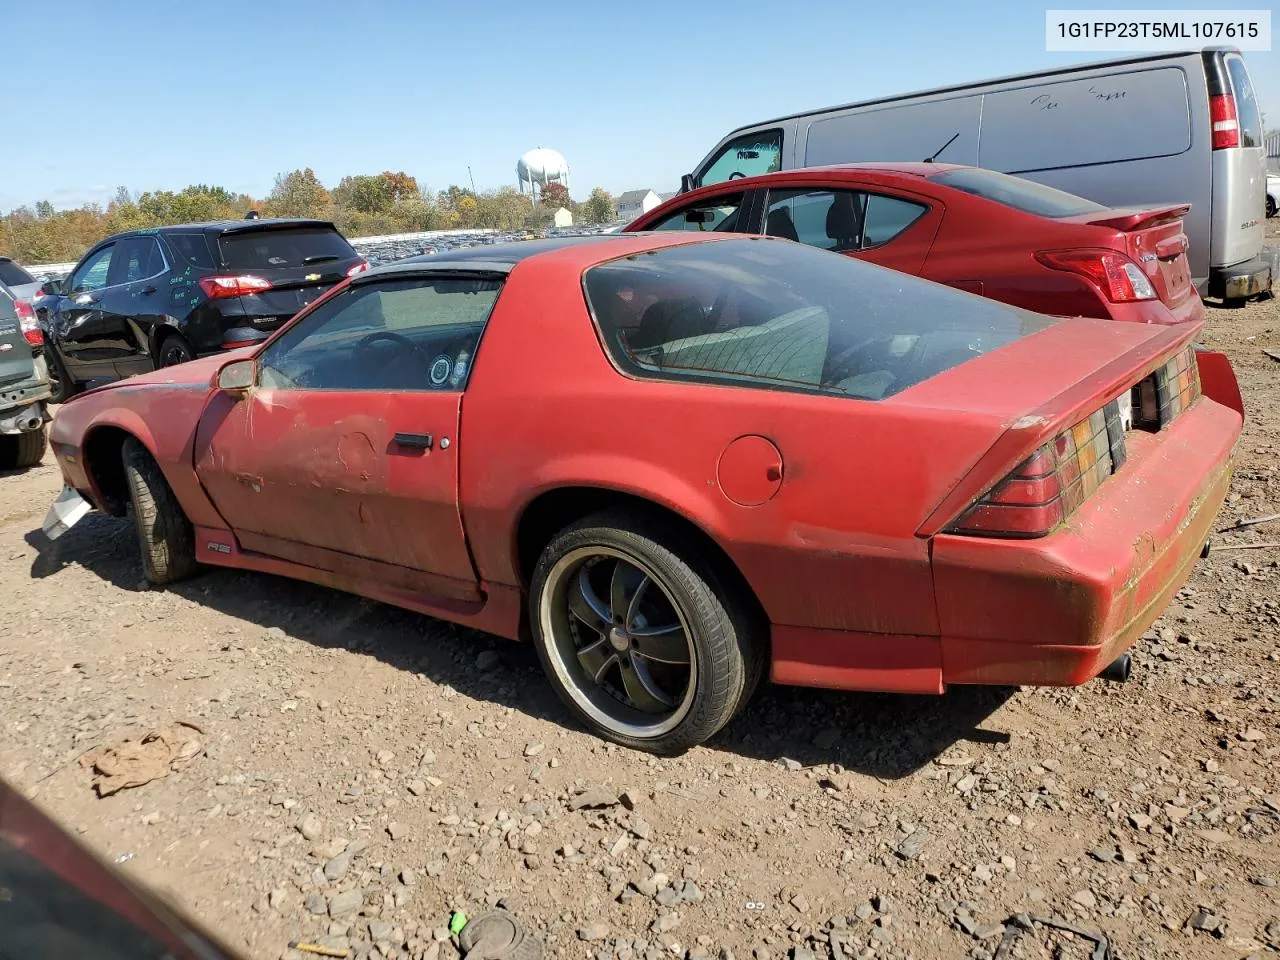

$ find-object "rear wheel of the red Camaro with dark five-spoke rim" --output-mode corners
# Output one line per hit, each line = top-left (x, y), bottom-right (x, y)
(530, 513), (764, 753)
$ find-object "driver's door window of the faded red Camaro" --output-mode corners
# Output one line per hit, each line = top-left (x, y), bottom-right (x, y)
(259, 276), (502, 390)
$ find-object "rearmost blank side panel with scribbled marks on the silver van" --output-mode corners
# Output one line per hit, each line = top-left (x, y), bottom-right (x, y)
(972, 67), (1203, 173)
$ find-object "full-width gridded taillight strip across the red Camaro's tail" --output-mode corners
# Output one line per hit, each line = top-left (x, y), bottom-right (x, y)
(947, 347), (1201, 539)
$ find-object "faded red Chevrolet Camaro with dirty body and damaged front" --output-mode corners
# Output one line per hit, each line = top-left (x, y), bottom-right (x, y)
(46, 233), (1242, 751)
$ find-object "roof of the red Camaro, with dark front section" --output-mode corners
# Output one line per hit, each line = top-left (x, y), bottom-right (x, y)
(352, 232), (711, 284)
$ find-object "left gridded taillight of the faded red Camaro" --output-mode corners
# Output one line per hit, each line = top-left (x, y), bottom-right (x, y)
(947, 401), (1126, 539)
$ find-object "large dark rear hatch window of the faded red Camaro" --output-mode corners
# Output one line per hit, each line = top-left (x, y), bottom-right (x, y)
(584, 238), (1057, 399)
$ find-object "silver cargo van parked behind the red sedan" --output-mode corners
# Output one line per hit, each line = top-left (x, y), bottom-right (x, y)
(681, 49), (1271, 300)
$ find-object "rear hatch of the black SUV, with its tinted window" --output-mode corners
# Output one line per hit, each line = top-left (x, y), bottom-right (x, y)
(218, 227), (361, 330)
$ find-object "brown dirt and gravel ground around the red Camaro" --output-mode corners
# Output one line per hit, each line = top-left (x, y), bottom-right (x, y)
(0, 267), (1280, 960)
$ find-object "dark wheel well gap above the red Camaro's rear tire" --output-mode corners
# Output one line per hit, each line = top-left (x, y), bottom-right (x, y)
(516, 486), (769, 632)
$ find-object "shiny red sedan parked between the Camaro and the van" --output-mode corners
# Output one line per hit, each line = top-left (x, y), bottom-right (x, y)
(634, 163), (1244, 413)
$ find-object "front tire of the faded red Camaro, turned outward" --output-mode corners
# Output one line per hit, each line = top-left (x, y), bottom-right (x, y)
(120, 436), (196, 586)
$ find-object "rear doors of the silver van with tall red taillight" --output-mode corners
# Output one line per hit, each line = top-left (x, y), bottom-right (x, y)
(1204, 50), (1267, 266)
